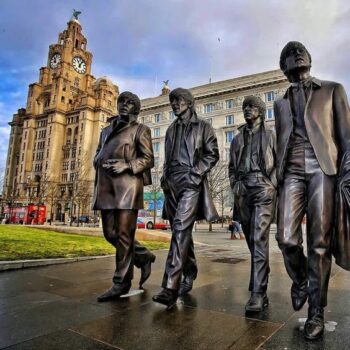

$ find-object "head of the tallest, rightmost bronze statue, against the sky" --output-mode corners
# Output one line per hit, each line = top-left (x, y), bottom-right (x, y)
(280, 41), (311, 76)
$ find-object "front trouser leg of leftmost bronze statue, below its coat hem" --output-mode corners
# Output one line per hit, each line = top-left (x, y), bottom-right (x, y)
(101, 209), (137, 284)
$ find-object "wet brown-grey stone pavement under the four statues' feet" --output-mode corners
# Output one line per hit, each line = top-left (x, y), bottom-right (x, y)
(0, 226), (350, 350)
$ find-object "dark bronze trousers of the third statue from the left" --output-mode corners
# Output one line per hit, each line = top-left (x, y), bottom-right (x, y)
(238, 177), (276, 293)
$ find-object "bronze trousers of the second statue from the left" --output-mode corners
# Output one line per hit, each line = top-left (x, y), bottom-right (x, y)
(162, 175), (200, 290)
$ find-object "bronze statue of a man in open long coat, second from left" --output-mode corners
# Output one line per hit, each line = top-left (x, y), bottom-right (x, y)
(153, 88), (219, 307)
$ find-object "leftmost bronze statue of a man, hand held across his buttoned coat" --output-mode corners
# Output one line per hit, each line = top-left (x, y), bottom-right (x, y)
(93, 91), (155, 302)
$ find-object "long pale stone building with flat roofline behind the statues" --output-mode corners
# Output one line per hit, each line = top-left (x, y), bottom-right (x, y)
(140, 70), (289, 215)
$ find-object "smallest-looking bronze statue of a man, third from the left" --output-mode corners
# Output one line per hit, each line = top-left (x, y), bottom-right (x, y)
(229, 96), (277, 312)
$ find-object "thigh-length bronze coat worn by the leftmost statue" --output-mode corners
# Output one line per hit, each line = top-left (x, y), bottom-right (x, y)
(93, 120), (154, 210)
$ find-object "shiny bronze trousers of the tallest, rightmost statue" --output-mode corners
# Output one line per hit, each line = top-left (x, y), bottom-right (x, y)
(276, 147), (335, 307)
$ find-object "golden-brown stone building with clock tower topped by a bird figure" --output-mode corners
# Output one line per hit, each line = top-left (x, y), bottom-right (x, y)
(4, 11), (119, 220)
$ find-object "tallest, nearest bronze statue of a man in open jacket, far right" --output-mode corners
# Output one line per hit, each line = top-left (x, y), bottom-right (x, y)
(274, 41), (350, 339)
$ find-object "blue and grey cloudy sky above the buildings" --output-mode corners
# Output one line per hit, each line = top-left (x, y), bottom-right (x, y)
(0, 0), (350, 171)
